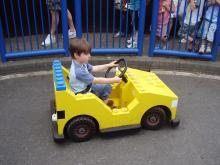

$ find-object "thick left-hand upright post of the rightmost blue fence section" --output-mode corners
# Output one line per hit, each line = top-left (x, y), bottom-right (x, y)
(149, 0), (159, 57)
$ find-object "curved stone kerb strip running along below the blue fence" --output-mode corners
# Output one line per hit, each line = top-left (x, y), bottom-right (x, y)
(0, 52), (220, 75)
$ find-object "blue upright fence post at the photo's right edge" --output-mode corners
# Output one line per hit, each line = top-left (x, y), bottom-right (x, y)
(212, 12), (220, 61)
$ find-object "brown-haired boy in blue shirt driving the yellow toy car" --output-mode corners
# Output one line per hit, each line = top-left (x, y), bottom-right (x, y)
(69, 38), (121, 107)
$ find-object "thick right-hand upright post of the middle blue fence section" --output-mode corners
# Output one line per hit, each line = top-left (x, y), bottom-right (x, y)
(138, 0), (146, 56)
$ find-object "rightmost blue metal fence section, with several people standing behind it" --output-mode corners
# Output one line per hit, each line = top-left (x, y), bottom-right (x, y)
(149, 0), (220, 61)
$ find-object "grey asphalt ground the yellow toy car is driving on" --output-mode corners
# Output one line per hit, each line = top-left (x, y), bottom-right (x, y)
(0, 72), (220, 165)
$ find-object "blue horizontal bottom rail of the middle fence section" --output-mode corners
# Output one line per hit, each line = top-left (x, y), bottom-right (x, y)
(92, 48), (138, 54)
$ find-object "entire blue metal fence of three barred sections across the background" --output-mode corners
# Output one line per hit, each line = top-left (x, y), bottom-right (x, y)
(0, 0), (220, 62)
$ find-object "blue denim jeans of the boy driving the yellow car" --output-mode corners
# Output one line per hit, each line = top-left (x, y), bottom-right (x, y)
(91, 84), (112, 100)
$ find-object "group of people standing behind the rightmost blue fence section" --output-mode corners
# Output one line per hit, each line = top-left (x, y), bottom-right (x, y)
(156, 0), (220, 53)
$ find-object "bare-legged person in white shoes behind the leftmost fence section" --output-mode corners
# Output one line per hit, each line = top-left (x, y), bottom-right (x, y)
(41, 0), (76, 46)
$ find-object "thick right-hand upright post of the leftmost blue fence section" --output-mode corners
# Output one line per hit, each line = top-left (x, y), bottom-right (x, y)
(61, 0), (69, 56)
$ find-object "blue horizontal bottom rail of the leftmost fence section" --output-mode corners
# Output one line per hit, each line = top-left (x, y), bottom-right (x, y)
(5, 48), (66, 59)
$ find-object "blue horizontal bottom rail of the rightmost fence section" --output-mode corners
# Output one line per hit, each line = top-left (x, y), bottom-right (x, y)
(154, 49), (212, 60)
